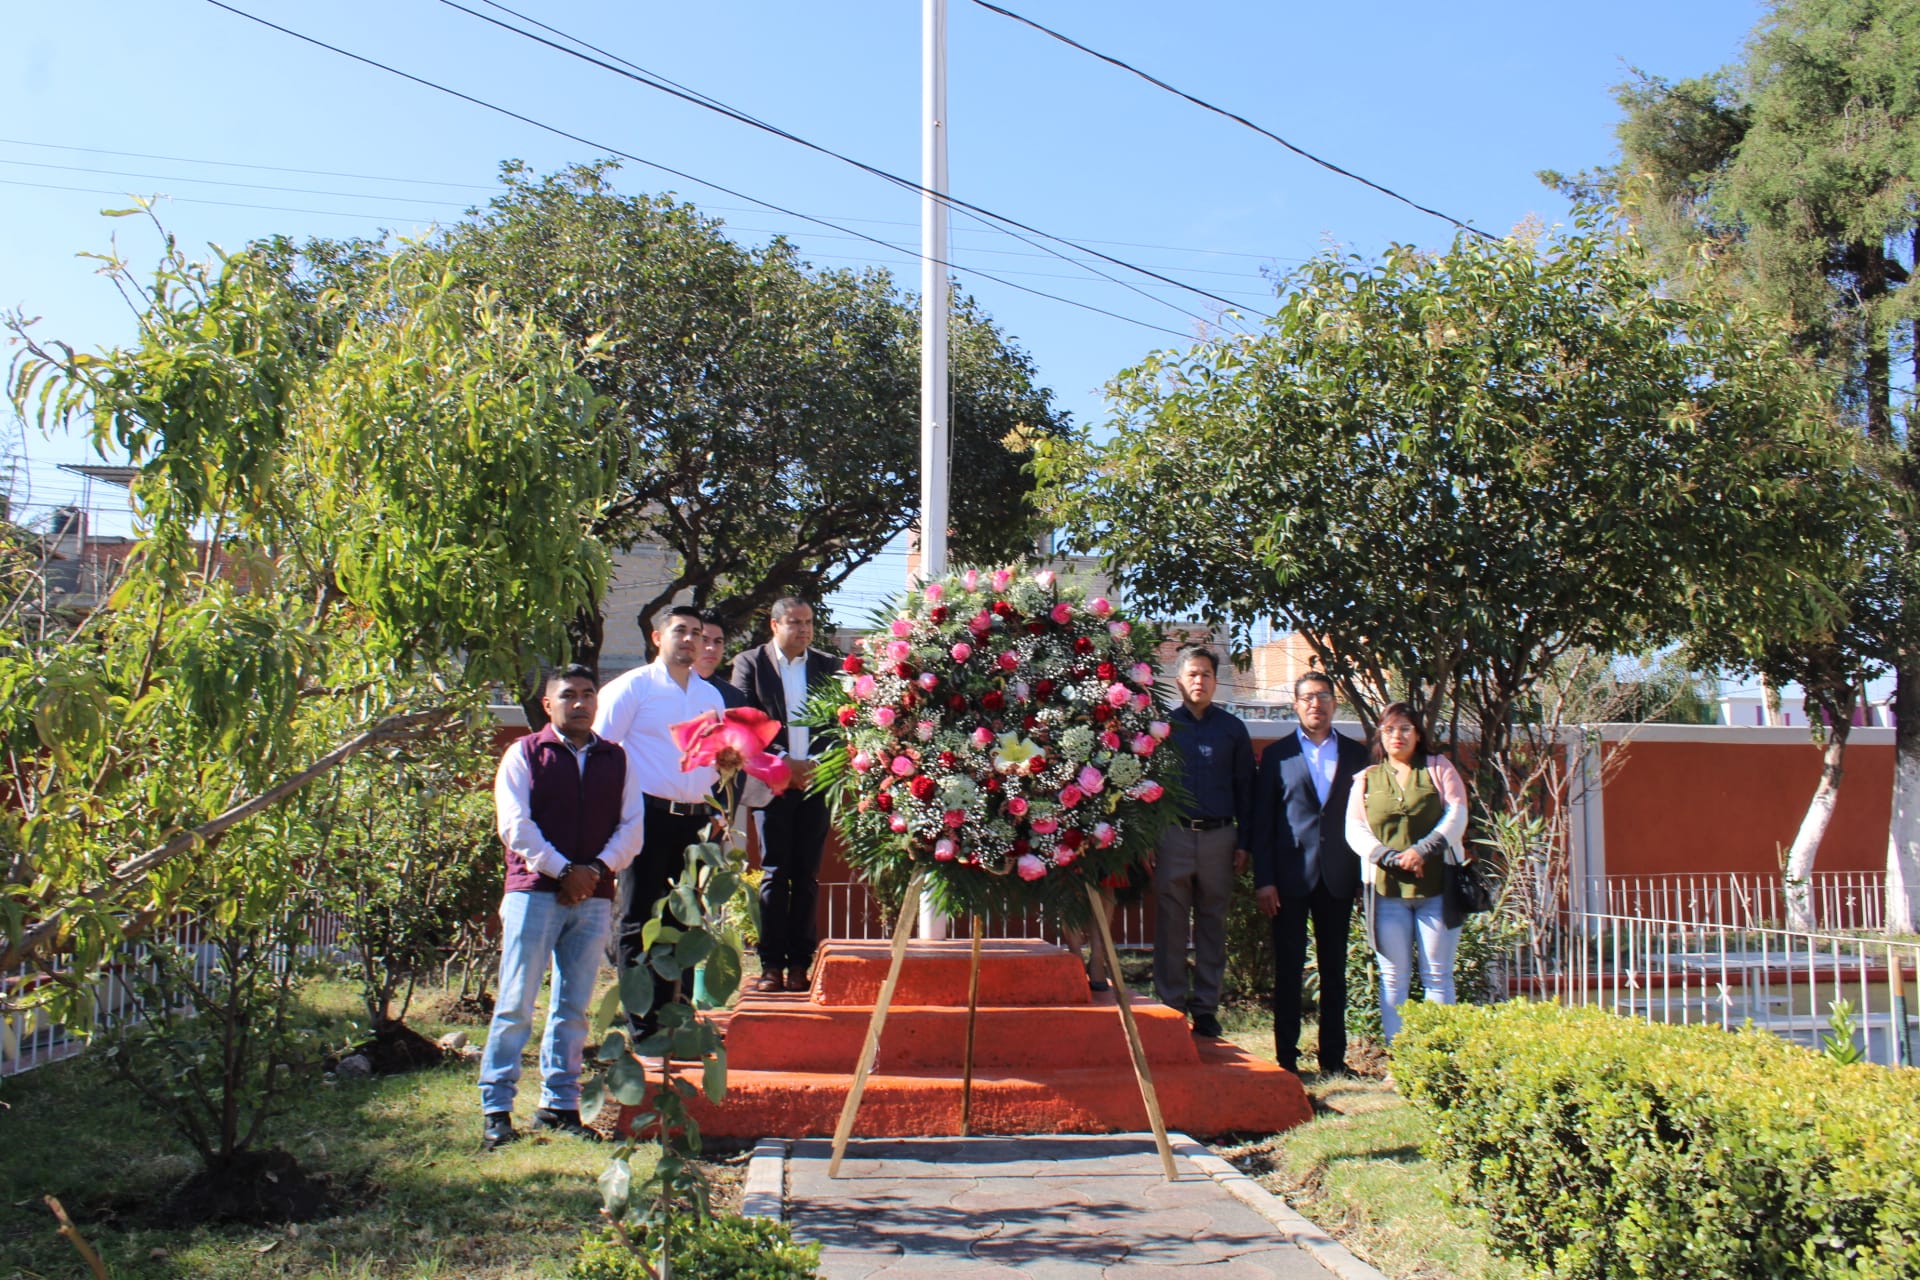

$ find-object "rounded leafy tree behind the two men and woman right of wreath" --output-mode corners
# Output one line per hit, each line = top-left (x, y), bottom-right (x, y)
(1043, 217), (1860, 817)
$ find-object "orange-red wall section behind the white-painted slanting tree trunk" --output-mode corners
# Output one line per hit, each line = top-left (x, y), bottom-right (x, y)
(1603, 741), (1893, 875)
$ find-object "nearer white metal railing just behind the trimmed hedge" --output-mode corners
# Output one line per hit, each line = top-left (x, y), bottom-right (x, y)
(1511, 912), (1920, 1067)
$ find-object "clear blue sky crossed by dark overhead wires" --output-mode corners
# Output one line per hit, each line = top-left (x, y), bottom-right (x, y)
(0, 0), (1761, 614)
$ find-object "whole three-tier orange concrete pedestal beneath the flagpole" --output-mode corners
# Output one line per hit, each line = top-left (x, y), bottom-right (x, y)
(622, 938), (1311, 1138)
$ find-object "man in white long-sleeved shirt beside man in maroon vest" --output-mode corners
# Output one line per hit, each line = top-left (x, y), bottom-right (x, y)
(593, 604), (726, 1036)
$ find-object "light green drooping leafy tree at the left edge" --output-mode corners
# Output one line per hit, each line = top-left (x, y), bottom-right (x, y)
(0, 222), (605, 1043)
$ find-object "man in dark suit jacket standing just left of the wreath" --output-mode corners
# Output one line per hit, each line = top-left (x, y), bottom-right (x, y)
(733, 597), (839, 992)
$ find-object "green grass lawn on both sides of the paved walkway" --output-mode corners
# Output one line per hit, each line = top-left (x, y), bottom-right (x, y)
(0, 958), (1523, 1280)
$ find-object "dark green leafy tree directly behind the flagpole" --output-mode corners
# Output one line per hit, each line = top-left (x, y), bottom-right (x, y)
(433, 163), (1066, 662)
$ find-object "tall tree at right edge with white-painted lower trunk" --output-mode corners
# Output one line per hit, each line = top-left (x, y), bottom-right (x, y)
(1546, 0), (1920, 931)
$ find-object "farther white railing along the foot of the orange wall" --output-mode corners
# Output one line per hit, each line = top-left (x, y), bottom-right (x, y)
(1590, 871), (1885, 931)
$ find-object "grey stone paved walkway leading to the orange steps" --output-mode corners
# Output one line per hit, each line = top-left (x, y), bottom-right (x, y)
(771, 1134), (1379, 1280)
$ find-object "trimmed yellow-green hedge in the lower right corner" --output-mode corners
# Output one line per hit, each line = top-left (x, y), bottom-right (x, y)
(1394, 1004), (1920, 1280)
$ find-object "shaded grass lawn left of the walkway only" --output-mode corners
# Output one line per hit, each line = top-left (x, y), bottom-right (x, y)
(0, 984), (687, 1280)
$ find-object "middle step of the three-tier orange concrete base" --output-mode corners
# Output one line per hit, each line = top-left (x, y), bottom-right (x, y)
(726, 981), (1200, 1075)
